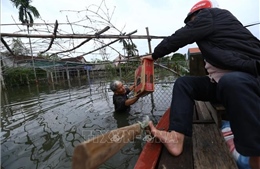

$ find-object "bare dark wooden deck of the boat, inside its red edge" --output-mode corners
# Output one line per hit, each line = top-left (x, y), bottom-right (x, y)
(157, 101), (238, 169)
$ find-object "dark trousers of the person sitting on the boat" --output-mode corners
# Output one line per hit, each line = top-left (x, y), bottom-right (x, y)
(169, 72), (260, 156)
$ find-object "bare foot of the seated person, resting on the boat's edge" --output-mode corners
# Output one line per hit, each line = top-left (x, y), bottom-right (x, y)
(149, 121), (184, 156)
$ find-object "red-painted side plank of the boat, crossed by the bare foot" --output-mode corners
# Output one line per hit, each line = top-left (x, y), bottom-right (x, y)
(134, 108), (170, 169)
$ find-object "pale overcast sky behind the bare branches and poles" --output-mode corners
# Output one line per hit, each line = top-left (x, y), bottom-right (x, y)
(1, 0), (260, 61)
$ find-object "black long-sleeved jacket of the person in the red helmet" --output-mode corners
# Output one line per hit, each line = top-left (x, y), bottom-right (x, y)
(152, 8), (260, 76)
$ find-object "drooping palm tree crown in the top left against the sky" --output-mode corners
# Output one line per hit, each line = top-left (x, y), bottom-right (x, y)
(10, 0), (40, 27)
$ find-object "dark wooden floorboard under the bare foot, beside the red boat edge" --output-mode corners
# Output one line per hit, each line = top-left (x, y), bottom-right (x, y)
(158, 137), (193, 169)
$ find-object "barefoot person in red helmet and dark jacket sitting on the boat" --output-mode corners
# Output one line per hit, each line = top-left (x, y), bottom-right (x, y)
(142, 0), (260, 169)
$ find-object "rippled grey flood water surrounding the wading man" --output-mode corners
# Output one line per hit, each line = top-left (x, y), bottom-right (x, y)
(1, 80), (172, 169)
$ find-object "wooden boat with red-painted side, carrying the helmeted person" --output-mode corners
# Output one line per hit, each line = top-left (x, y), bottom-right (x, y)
(134, 101), (237, 169)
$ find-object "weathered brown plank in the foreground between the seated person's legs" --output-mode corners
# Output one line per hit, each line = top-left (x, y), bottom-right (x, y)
(192, 124), (237, 169)
